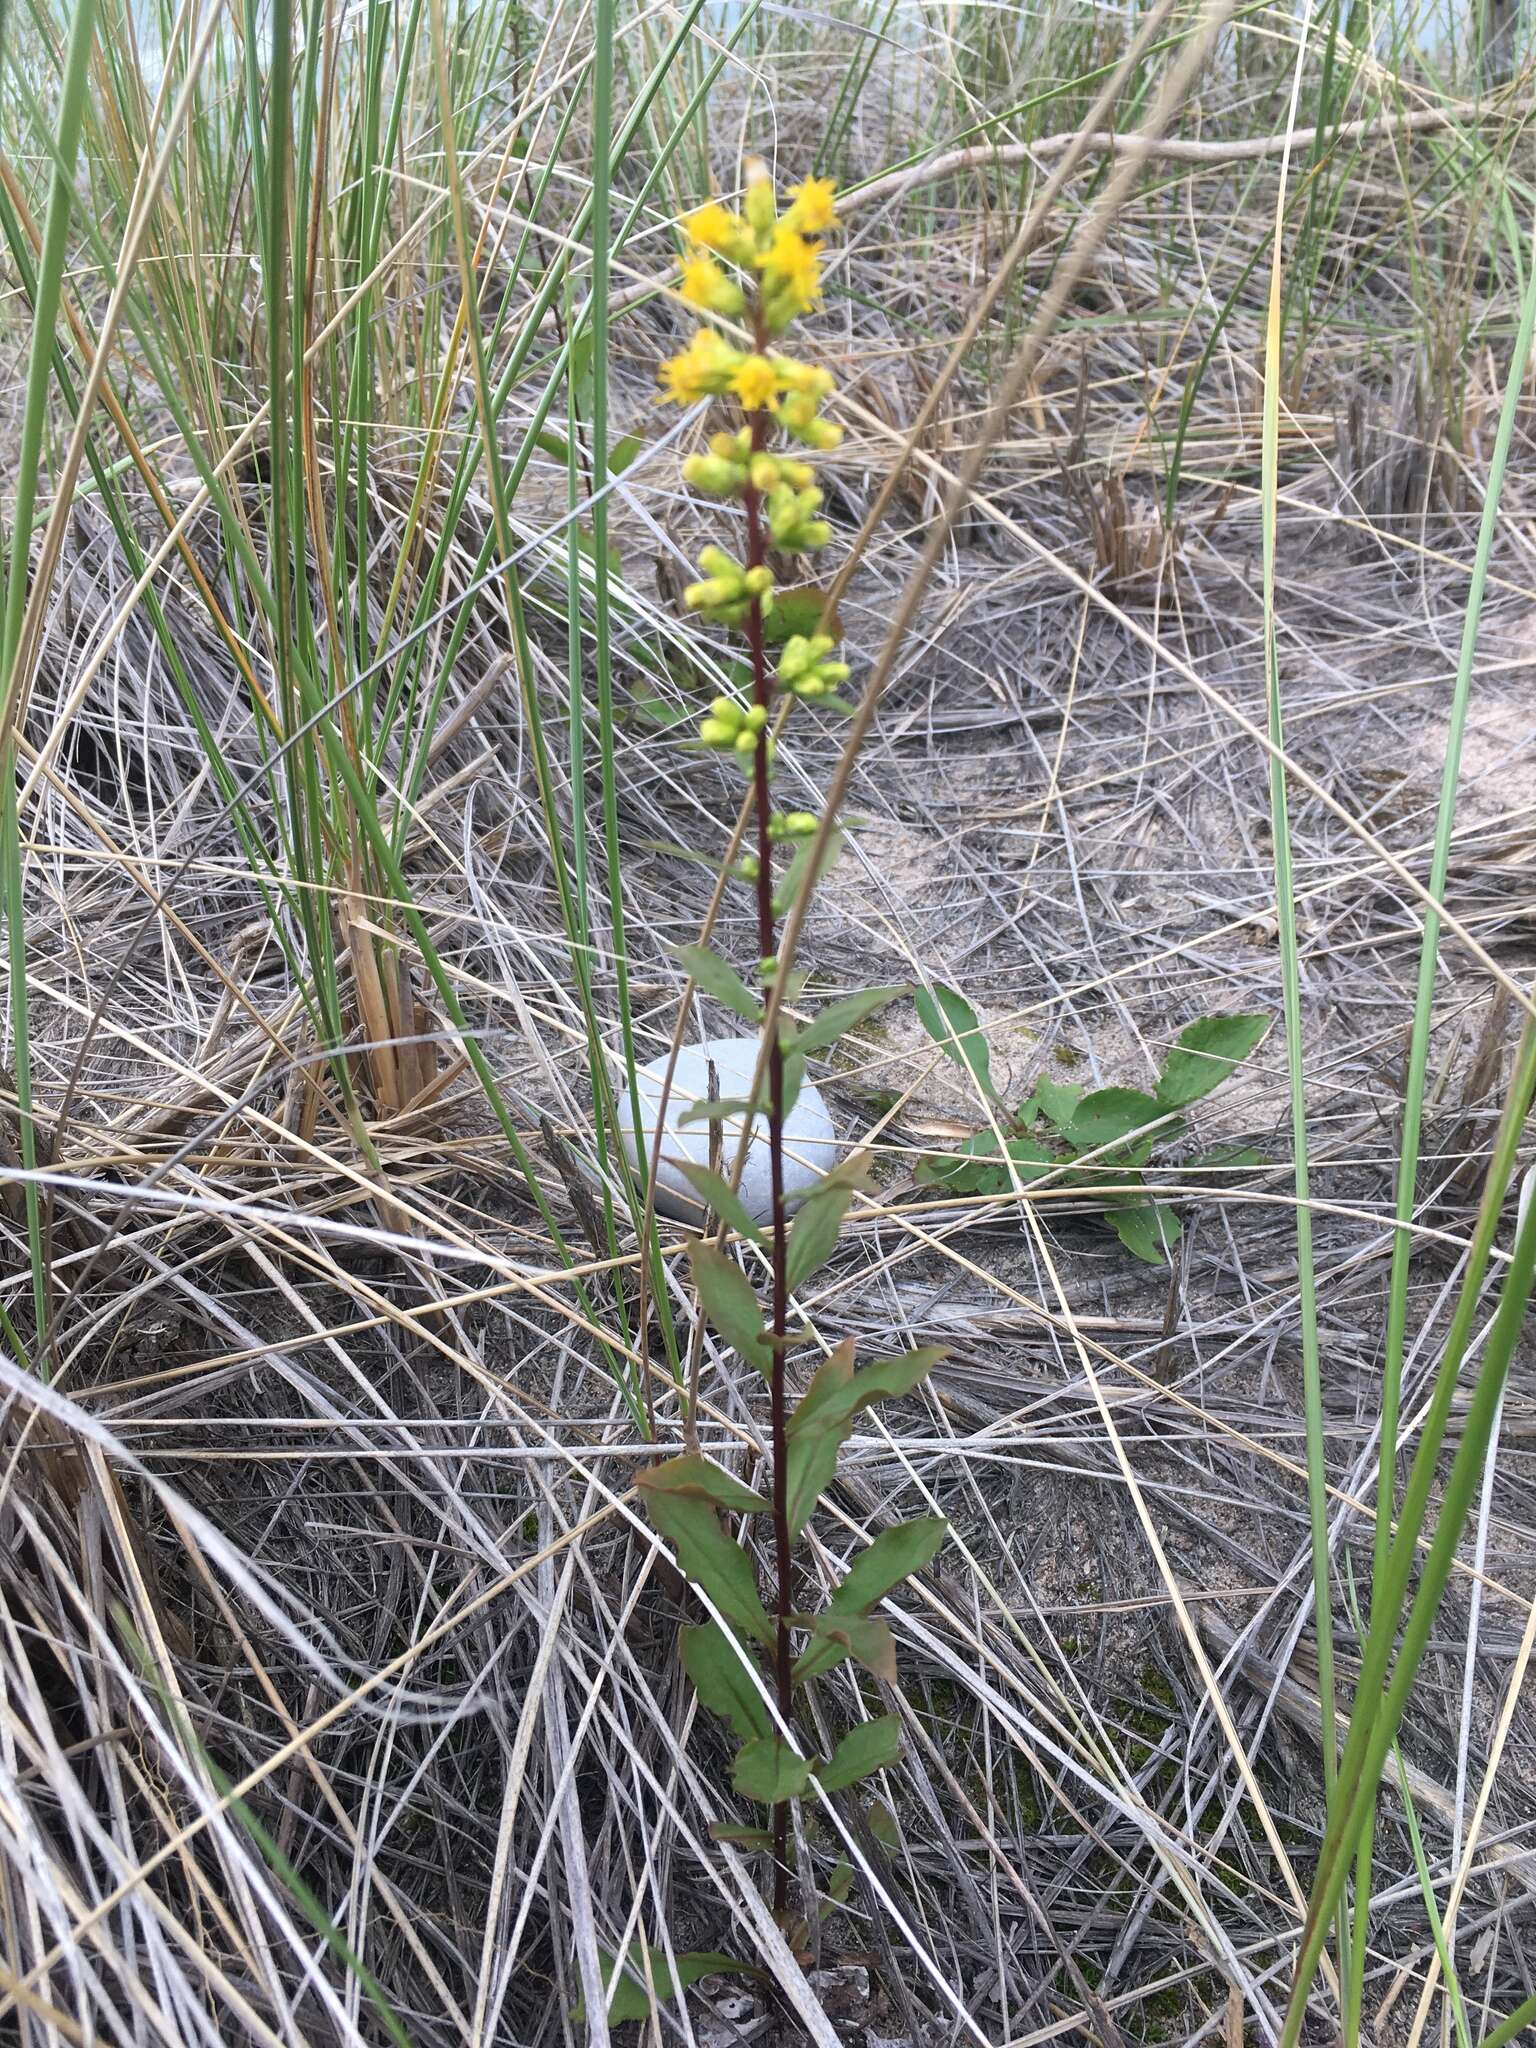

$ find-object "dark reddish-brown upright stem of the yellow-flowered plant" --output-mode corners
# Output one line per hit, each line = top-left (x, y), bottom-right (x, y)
(743, 330), (795, 1921)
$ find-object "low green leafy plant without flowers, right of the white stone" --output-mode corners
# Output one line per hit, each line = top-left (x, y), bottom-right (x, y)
(918, 985), (1270, 1266)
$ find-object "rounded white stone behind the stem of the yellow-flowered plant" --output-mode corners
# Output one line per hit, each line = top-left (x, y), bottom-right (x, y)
(614, 1038), (838, 1223)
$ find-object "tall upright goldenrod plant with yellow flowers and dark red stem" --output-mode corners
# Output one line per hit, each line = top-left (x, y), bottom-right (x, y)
(629, 164), (946, 1982)
